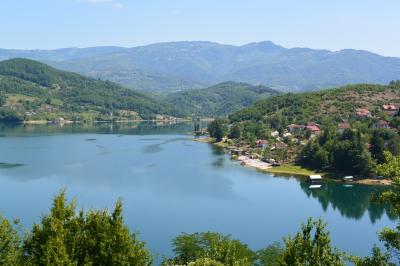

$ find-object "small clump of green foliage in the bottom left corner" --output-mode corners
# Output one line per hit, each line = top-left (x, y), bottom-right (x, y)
(0, 215), (22, 266)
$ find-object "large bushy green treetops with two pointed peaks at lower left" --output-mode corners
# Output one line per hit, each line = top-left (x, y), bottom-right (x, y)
(23, 192), (152, 265)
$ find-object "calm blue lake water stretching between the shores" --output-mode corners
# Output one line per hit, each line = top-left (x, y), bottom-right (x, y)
(0, 124), (395, 262)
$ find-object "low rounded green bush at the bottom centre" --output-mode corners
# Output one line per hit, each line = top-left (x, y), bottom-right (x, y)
(164, 232), (255, 266)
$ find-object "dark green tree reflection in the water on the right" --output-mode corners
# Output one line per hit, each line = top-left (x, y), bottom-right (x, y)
(300, 182), (396, 223)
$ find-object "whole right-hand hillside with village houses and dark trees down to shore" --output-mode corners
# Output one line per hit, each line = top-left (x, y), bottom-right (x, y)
(208, 81), (400, 177)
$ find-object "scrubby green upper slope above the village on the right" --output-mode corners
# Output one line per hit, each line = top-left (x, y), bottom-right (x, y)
(229, 81), (400, 127)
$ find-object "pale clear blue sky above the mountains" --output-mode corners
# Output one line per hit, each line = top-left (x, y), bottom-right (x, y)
(0, 0), (400, 57)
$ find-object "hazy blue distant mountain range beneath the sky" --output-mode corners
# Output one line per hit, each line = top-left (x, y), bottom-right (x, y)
(0, 41), (400, 92)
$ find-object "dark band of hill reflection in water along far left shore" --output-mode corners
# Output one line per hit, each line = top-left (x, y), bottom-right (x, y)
(0, 122), (206, 137)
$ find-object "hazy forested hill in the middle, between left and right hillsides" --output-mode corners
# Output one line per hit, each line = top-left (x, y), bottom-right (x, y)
(164, 82), (279, 117)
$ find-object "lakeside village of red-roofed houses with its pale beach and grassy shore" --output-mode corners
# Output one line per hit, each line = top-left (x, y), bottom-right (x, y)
(196, 103), (399, 185)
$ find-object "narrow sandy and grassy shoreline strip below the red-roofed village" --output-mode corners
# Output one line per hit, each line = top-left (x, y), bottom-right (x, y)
(194, 137), (392, 186)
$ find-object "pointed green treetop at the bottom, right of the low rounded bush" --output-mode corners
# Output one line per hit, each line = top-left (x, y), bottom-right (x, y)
(283, 219), (344, 266)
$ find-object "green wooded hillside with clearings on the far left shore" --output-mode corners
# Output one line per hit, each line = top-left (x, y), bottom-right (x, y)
(0, 59), (179, 121)
